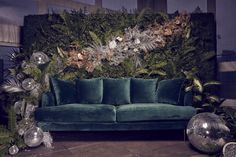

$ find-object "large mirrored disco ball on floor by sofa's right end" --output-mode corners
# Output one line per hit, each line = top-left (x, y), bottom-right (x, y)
(187, 113), (230, 154)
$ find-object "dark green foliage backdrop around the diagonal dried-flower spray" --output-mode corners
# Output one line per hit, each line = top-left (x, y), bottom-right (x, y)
(23, 11), (216, 79)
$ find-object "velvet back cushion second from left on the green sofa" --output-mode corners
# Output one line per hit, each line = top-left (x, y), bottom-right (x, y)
(76, 78), (103, 104)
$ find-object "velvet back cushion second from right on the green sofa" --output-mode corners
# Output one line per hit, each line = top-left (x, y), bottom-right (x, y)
(130, 78), (158, 103)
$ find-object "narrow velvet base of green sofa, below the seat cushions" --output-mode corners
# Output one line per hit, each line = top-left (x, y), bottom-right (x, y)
(37, 120), (188, 131)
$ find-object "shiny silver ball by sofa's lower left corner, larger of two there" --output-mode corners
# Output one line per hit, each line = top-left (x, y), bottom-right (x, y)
(24, 127), (43, 147)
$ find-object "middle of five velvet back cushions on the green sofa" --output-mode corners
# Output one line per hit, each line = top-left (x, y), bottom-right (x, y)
(103, 78), (130, 105)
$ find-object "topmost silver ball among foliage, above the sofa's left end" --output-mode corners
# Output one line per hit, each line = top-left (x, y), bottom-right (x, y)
(30, 51), (49, 65)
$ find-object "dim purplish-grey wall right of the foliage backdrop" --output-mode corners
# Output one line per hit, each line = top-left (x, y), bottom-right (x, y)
(216, 0), (236, 105)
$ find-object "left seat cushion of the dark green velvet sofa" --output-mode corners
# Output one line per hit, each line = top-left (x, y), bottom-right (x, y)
(35, 104), (116, 122)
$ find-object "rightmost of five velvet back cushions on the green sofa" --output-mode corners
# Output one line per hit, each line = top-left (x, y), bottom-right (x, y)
(156, 78), (185, 105)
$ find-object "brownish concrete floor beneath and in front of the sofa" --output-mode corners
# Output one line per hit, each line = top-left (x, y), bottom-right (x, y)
(8, 131), (205, 157)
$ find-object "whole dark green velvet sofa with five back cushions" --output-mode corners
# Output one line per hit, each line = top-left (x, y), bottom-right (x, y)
(35, 78), (196, 131)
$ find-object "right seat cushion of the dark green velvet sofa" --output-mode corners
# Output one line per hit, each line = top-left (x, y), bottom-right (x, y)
(116, 103), (196, 122)
